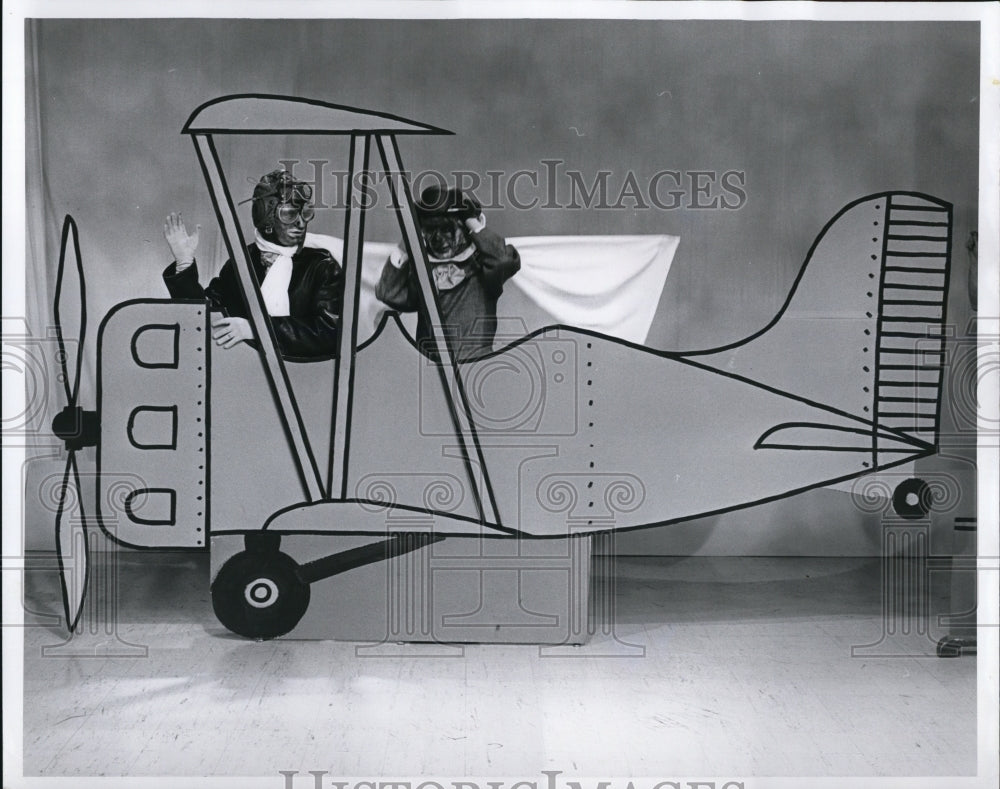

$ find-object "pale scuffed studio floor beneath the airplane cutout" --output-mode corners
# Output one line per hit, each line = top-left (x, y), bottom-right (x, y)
(17, 553), (976, 785)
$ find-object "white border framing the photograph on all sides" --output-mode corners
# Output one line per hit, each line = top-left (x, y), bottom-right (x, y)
(2, 0), (1000, 789)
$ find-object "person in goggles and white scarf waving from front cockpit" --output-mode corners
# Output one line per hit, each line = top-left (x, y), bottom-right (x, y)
(163, 169), (342, 357)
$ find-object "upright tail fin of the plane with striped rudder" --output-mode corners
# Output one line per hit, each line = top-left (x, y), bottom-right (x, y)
(685, 192), (952, 448)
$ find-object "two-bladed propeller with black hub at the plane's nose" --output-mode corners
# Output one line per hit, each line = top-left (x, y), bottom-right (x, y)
(52, 214), (100, 632)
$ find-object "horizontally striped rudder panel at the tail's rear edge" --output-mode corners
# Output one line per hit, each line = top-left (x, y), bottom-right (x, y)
(873, 193), (951, 446)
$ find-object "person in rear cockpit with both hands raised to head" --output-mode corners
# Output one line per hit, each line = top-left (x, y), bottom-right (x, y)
(375, 186), (521, 361)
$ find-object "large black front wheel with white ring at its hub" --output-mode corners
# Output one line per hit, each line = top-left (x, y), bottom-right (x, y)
(212, 551), (309, 639)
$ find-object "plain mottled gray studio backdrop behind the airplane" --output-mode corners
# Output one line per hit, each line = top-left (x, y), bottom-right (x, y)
(23, 20), (979, 555)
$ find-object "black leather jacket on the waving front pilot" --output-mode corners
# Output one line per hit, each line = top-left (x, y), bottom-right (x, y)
(163, 244), (343, 357)
